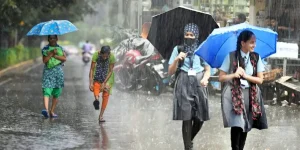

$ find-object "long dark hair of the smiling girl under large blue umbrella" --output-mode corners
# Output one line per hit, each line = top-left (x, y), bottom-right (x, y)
(236, 30), (254, 68)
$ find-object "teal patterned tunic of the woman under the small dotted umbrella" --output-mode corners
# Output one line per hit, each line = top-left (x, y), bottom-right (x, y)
(42, 45), (64, 88)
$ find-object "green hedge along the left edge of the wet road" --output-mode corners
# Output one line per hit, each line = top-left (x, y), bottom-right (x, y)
(0, 44), (41, 70)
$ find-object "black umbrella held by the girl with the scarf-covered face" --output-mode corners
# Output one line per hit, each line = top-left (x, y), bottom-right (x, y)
(148, 6), (219, 59)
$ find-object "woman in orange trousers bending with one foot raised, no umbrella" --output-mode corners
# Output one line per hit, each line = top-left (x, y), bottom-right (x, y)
(89, 46), (116, 122)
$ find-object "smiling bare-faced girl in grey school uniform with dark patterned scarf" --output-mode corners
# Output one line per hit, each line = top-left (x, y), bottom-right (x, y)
(219, 30), (268, 150)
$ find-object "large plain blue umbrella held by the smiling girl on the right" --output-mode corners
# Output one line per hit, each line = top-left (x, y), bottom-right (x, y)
(196, 23), (278, 68)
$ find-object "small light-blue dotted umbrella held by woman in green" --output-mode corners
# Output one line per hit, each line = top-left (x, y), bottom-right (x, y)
(27, 20), (78, 36)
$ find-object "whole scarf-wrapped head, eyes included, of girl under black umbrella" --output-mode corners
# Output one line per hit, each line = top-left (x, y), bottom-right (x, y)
(184, 23), (199, 55)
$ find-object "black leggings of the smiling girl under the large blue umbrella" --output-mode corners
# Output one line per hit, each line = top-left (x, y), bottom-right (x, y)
(231, 127), (248, 150)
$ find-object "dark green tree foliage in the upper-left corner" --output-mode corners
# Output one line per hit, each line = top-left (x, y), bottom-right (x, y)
(0, 0), (98, 47)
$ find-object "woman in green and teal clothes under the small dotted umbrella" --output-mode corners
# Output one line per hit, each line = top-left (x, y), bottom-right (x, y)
(42, 35), (66, 118)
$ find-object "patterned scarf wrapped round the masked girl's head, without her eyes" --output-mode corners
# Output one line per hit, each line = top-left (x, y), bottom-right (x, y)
(184, 23), (199, 55)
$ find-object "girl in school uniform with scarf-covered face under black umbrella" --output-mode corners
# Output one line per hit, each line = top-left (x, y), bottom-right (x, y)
(169, 23), (210, 150)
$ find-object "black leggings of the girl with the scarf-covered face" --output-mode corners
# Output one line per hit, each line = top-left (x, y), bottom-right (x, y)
(182, 118), (204, 150)
